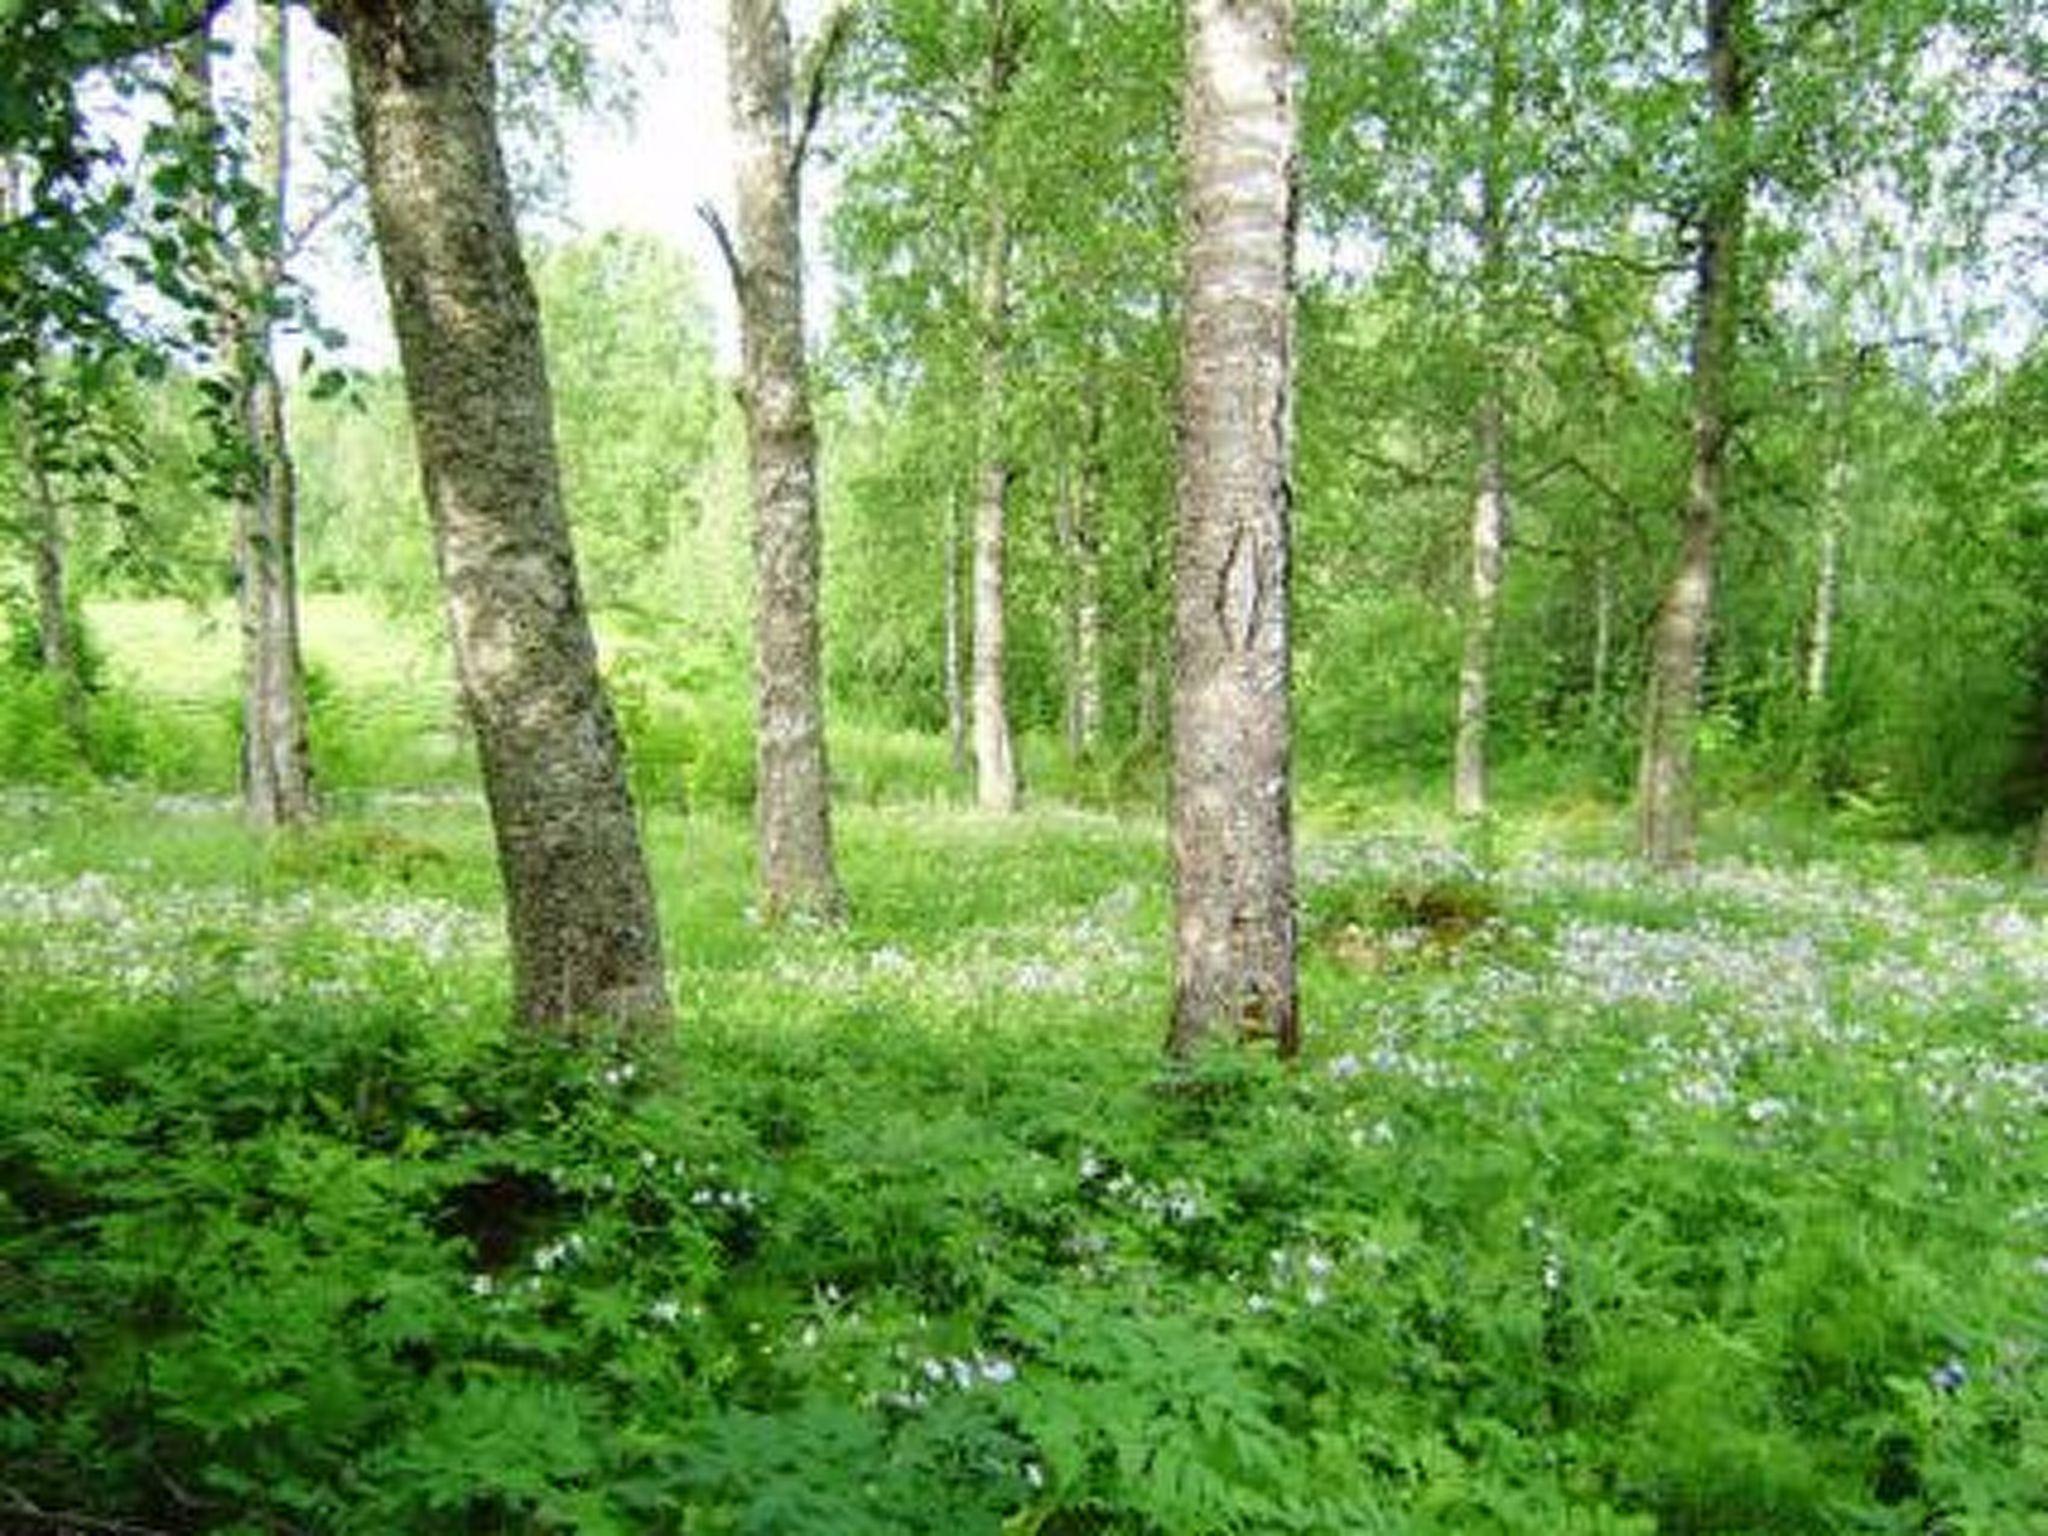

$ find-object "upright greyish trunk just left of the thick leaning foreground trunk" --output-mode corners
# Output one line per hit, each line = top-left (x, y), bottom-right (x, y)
(229, 0), (313, 827)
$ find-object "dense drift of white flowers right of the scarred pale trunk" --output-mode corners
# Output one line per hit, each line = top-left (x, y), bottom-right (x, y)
(1305, 840), (2048, 1147)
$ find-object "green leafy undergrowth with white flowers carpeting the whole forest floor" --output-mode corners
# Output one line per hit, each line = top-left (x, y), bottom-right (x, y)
(0, 797), (2048, 1536)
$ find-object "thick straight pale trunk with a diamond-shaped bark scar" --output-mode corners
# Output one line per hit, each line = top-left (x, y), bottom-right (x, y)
(1167, 0), (1300, 1055)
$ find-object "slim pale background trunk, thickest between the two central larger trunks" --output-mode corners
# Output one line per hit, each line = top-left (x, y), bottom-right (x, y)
(973, 0), (1018, 813)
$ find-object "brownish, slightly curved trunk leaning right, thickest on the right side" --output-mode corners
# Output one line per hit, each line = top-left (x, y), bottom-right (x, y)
(1636, 0), (1749, 868)
